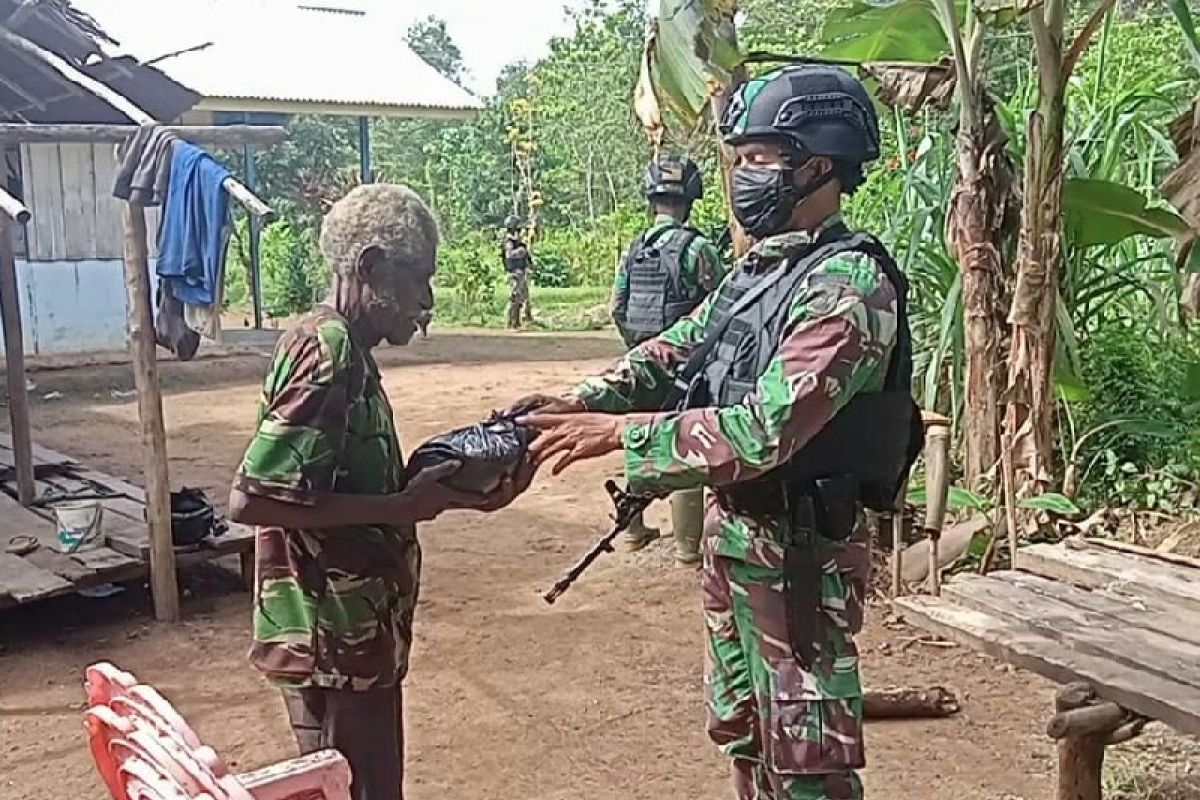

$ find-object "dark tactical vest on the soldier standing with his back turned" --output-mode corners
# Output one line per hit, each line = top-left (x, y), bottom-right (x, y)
(613, 225), (704, 345)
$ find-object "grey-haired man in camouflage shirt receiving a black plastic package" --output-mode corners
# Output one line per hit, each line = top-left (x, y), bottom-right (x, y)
(229, 184), (515, 800)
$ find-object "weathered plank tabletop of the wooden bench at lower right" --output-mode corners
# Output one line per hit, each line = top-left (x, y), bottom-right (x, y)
(895, 539), (1200, 735)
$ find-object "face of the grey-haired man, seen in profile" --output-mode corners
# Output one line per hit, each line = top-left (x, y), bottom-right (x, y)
(359, 247), (437, 344)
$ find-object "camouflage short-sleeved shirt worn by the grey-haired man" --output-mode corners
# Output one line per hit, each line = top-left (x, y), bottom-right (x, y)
(234, 307), (421, 691)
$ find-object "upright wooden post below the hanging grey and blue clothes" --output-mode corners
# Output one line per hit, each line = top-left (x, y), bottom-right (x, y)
(125, 203), (179, 622)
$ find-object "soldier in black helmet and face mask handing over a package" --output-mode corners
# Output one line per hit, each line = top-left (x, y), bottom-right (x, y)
(511, 66), (914, 800)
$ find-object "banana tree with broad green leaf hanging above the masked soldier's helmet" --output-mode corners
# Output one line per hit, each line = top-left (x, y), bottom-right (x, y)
(823, 0), (1015, 488)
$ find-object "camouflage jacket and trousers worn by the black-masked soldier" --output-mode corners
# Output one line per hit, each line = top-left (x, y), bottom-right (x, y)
(575, 218), (896, 786)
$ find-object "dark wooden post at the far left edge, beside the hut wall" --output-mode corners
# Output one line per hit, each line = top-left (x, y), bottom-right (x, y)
(0, 213), (37, 506)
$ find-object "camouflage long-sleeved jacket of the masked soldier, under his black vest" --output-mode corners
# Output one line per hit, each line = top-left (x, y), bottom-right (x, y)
(575, 218), (896, 571)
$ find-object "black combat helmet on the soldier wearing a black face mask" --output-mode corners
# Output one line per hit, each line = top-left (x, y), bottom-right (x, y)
(720, 64), (880, 164)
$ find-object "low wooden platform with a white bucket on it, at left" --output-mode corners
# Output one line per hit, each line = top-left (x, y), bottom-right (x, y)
(0, 434), (254, 608)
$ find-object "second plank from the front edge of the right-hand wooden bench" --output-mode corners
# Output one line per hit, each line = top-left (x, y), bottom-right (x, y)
(942, 576), (1200, 690)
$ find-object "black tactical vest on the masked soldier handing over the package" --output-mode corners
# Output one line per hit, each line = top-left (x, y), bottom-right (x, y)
(685, 228), (924, 512)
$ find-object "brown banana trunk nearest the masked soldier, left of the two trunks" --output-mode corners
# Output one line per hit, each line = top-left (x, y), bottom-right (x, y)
(946, 112), (1010, 489)
